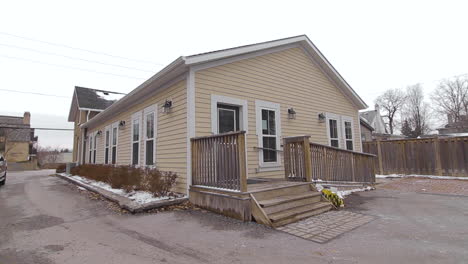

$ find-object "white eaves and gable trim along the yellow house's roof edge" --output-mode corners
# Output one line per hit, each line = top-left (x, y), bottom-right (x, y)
(81, 35), (368, 128)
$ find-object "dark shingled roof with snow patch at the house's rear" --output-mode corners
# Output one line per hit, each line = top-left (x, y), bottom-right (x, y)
(75, 86), (125, 110)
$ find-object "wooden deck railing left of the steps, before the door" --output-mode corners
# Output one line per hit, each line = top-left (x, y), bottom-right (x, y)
(191, 131), (247, 192)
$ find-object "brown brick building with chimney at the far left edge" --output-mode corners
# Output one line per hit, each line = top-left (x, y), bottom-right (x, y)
(0, 112), (37, 162)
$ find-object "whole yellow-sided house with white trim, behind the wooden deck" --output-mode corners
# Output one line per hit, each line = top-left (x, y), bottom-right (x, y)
(69, 35), (367, 193)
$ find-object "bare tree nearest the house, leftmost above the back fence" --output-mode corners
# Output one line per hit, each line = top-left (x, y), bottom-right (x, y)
(375, 89), (406, 134)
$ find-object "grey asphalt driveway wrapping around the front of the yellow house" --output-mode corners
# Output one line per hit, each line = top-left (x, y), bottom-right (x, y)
(0, 170), (468, 264)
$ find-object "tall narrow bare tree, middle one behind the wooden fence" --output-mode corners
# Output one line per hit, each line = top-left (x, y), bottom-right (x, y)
(402, 84), (431, 138)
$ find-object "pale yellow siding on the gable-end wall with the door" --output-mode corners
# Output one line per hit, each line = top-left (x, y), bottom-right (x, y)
(195, 48), (361, 177)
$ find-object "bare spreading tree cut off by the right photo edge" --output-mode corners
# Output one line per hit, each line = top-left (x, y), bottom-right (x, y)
(431, 75), (468, 122)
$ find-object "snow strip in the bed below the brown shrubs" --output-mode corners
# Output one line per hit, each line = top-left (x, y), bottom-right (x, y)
(68, 173), (175, 204)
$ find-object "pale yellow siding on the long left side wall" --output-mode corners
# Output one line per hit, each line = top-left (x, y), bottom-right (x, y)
(89, 80), (187, 193)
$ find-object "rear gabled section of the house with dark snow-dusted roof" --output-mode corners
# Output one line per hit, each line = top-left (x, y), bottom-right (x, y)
(68, 86), (125, 162)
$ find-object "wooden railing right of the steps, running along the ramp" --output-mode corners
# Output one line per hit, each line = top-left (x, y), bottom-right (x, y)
(284, 136), (376, 183)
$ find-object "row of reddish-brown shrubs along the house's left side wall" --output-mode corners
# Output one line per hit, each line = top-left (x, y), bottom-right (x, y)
(71, 164), (177, 196)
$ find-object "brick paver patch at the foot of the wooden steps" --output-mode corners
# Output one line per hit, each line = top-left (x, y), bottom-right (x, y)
(277, 209), (375, 243)
